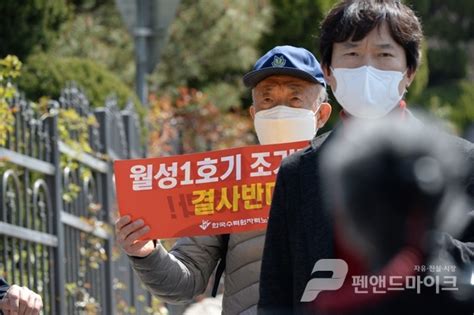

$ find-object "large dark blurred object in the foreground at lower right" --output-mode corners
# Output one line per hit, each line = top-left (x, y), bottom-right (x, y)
(316, 119), (474, 314)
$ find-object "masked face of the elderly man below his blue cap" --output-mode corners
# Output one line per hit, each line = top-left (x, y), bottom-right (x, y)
(250, 75), (331, 144)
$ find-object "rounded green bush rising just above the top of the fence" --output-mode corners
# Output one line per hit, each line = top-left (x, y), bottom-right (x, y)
(18, 54), (143, 115)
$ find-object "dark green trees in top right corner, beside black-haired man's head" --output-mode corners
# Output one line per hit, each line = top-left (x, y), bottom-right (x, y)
(407, 0), (474, 132)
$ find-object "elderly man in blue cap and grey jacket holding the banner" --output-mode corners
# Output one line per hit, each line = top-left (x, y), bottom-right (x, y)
(116, 46), (331, 314)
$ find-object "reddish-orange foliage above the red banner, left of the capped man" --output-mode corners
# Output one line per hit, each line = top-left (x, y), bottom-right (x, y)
(148, 88), (255, 156)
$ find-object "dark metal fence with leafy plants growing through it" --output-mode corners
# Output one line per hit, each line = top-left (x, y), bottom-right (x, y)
(0, 85), (151, 314)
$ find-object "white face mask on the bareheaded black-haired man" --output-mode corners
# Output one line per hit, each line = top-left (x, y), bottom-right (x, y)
(332, 66), (406, 119)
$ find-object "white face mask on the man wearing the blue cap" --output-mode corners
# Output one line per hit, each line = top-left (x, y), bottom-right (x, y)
(254, 105), (317, 144)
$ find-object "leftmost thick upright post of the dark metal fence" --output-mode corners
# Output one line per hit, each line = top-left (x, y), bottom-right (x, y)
(48, 107), (66, 314)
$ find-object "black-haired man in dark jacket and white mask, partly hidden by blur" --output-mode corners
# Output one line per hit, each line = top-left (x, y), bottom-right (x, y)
(259, 0), (474, 314)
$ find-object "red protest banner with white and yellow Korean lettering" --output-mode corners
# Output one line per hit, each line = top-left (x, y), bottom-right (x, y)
(114, 141), (308, 239)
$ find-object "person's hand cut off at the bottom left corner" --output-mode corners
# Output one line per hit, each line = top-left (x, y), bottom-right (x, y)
(0, 278), (43, 315)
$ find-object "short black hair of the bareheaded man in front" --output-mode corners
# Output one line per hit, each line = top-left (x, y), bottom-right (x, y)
(319, 0), (423, 71)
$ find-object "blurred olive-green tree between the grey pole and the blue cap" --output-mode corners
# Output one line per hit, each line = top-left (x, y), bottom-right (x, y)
(152, 0), (271, 108)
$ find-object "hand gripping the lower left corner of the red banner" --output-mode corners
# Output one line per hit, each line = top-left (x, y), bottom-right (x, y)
(115, 215), (155, 257)
